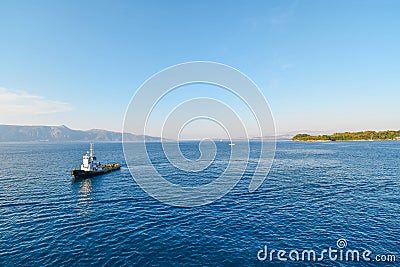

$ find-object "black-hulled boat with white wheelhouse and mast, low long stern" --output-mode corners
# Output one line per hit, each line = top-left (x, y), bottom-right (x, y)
(71, 143), (121, 179)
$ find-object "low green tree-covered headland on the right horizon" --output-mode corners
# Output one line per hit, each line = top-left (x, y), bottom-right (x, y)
(292, 130), (400, 142)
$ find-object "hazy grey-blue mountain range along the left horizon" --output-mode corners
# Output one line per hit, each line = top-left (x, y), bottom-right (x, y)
(0, 125), (160, 142)
